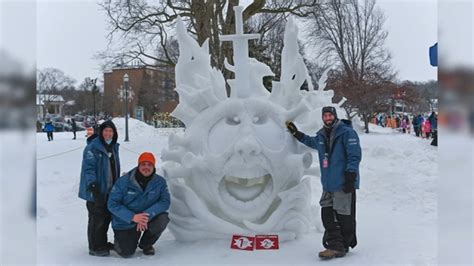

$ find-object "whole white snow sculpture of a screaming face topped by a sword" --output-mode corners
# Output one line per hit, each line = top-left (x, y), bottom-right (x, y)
(162, 7), (342, 241)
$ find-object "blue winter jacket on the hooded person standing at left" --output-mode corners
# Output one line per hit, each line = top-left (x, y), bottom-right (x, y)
(79, 137), (120, 201)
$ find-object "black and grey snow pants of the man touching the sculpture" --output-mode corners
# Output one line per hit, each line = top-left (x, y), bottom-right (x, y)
(319, 191), (357, 252)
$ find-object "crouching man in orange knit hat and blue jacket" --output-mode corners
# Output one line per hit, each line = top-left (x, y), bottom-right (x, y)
(108, 152), (170, 258)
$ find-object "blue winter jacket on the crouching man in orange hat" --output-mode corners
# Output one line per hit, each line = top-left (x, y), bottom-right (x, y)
(107, 168), (170, 230)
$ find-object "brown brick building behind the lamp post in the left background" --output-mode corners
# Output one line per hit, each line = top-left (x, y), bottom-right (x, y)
(103, 65), (178, 121)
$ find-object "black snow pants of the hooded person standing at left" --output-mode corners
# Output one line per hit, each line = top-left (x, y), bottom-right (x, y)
(86, 201), (112, 251)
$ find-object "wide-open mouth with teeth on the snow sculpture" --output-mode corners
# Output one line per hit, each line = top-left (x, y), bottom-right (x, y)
(219, 174), (273, 206)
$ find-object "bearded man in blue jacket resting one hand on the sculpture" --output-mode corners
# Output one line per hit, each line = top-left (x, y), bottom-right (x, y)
(287, 106), (362, 259)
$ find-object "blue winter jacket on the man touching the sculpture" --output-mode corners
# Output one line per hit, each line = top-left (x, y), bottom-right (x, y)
(301, 119), (362, 192)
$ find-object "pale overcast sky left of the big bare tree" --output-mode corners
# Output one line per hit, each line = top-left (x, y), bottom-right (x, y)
(37, 0), (107, 82)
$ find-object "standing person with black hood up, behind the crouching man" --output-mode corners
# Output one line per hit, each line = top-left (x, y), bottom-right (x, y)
(79, 121), (120, 256)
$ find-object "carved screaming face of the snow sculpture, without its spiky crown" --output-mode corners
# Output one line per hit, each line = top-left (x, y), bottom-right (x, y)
(178, 99), (312, 224)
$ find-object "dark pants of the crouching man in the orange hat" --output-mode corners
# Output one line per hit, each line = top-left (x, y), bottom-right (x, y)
(114, 213), (170, 258)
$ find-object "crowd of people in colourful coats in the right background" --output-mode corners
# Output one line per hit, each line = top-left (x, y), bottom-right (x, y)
(372, 112), (438, 146)
